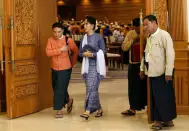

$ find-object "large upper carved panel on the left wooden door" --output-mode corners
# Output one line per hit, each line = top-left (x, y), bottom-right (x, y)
(15, 0), (37, 44)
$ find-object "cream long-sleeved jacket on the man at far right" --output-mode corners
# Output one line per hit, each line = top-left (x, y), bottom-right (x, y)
(140, 28), (175, 77)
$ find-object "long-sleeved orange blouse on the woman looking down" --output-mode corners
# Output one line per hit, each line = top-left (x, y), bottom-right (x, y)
(46, 36), (78, 70)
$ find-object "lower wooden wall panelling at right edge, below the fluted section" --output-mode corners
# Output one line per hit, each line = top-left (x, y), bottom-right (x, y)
(174, 41), (189, 115)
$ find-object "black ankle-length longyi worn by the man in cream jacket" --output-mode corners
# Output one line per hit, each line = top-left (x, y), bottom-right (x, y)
(150, 75), (177, 121)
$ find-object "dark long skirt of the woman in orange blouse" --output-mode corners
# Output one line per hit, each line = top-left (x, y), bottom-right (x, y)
(52, 68), (72, 110)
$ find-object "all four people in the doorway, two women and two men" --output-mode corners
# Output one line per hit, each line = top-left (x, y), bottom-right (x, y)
(46, 15), (176, 130)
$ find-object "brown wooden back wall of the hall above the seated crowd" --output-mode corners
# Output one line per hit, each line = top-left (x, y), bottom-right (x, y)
(76, 0), (145, 24)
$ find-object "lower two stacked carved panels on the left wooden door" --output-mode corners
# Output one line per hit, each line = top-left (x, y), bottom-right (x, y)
(13, 60), (39, 98)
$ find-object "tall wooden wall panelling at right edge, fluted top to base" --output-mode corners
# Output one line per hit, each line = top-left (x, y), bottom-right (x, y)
(167, 0), (189, 115)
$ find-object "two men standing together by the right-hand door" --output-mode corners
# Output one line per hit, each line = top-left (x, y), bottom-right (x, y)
(121, 15), (177, 130)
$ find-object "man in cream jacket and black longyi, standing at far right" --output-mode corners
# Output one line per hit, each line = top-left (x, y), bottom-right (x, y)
(140, 15), (176, 130)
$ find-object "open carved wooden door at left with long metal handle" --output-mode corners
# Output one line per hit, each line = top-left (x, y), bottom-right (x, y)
(4, 0), (56, 118)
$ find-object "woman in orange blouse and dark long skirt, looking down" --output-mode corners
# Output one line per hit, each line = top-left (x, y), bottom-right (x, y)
(46, 23), (78, 118)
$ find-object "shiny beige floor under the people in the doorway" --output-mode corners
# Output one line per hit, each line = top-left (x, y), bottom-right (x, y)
(0, 79), (189, 131)
